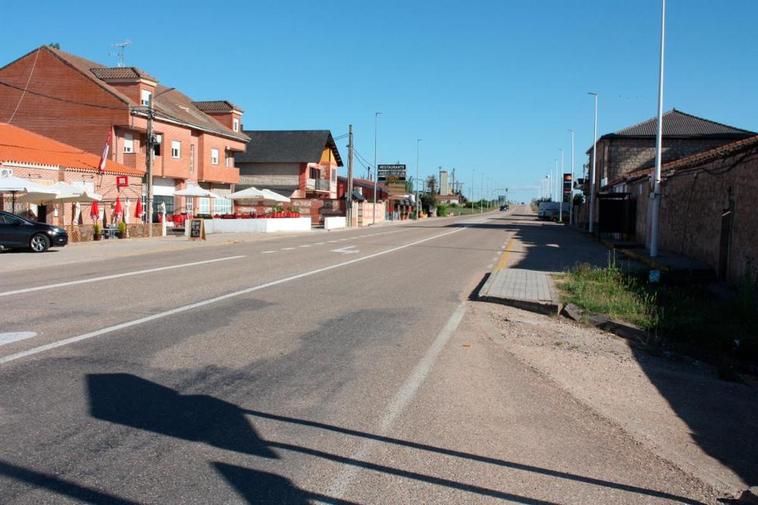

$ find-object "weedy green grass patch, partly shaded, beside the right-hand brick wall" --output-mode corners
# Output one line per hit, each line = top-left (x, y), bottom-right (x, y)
(557, 265), (758, 365)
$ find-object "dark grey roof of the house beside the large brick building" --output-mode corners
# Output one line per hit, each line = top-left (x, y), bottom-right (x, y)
(235, 130), (342, 167)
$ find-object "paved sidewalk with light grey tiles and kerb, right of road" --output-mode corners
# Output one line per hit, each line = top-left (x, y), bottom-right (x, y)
(479, 206), (609, 315)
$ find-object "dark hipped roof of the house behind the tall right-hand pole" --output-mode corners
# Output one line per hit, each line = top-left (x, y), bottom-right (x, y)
(616, 109), (755, 138)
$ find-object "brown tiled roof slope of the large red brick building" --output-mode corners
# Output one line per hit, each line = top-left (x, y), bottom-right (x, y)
(40, 46), (248, 142)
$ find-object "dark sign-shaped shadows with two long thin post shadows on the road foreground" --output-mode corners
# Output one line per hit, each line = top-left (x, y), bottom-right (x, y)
(81, 374), (699, 505)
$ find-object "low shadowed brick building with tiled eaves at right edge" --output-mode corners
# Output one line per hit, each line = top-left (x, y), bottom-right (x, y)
(624, 136), (758, 282)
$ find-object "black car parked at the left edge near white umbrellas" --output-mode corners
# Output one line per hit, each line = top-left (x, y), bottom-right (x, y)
(0, 210), (68, 252)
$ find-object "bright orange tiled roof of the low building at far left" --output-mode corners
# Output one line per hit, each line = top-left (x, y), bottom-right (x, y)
(0, 123), (144, 176)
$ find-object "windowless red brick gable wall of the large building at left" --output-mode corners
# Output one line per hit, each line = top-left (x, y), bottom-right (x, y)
(0, 48), (129, 154)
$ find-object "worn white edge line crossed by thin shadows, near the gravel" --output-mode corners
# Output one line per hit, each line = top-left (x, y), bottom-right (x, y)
(325, 302), (466, 494)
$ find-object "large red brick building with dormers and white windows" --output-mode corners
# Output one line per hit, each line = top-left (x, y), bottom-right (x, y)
(0, 46), (248, 219)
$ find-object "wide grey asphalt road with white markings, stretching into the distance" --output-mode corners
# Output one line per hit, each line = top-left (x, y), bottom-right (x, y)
(0, 208), (711, 504)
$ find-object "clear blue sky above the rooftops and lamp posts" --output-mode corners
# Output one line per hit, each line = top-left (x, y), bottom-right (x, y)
(0, 0), (758, 200)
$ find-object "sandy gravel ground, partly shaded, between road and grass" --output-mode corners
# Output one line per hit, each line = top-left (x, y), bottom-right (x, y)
(482, 304), (758, 497)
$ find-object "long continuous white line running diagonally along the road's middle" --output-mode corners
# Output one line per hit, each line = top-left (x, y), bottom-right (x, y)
(0, 228), (465, 365)
